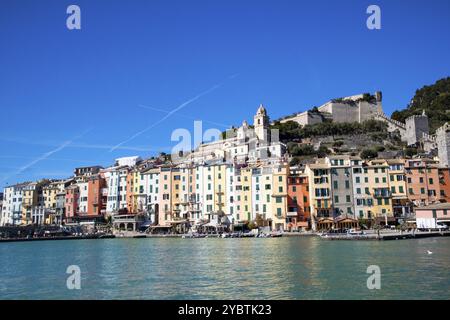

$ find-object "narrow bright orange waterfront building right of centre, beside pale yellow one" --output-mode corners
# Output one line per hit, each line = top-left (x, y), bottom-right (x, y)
(287, 167), (310, 230)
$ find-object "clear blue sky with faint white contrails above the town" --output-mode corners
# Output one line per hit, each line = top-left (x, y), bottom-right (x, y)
(0, 0), (450, 187)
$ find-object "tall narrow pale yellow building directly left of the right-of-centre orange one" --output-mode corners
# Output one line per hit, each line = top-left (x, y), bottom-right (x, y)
(272, 164), (289, 230)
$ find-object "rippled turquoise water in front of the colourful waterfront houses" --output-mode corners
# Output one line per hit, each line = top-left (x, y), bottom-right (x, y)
(0, 237), (450, 299)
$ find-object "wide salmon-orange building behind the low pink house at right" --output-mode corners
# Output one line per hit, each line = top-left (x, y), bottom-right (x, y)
(405, 159), (440, 205)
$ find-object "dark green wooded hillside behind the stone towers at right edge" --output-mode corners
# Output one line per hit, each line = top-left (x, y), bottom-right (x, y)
(392, 77), (450, 133)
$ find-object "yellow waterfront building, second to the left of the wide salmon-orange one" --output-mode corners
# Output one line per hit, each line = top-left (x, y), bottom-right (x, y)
(366, 159), (393, 223)
